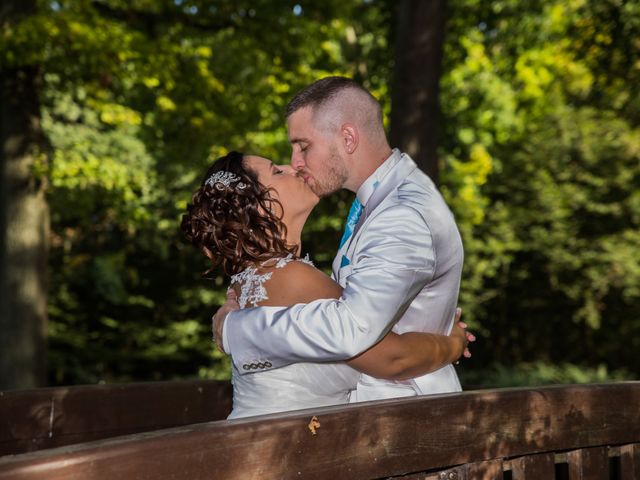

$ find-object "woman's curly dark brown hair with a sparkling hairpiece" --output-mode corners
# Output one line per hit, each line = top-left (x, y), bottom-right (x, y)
(180, 152), (297, 276)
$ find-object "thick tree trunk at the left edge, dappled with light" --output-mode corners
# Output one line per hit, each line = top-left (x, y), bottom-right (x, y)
(0, 0), (49, 390)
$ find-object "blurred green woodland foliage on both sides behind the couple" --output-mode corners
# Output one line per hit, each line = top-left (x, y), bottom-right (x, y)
(0, 0), (640, 388)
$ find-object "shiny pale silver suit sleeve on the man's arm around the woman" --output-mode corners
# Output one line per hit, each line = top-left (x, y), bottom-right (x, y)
(224, 205), (435, 373)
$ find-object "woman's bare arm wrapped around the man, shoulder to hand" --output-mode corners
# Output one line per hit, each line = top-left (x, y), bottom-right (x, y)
(260, 262), (467, 380)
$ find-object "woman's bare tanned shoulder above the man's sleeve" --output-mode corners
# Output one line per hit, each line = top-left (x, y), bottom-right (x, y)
(261, 261), (342, 306)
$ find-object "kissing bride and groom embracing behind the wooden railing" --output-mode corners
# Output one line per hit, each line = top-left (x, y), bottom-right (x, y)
(181, 77), (474, 419)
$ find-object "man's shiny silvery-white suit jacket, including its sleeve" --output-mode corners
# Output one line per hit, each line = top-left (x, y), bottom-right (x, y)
(223, 149), (463, 401)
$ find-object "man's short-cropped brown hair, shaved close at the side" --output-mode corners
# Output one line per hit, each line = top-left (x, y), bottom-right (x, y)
(285, 76), (384, 136)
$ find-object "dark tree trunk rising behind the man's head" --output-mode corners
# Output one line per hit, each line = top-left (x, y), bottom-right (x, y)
(390, 0), (446, 182)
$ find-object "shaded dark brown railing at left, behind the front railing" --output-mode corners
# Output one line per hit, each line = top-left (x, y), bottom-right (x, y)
(0, 380), (232, 456)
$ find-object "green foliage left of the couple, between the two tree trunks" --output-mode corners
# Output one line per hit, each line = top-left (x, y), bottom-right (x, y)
(0, 0), (390, 384)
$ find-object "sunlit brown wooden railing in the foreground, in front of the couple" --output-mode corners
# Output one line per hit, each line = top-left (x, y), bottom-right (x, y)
(0, 382), (640, 480)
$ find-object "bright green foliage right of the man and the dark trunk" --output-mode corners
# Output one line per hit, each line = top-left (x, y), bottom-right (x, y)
(442, 0), (640, 381)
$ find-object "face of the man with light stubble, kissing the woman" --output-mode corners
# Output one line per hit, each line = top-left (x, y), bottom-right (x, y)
(287, 108), (348, 197)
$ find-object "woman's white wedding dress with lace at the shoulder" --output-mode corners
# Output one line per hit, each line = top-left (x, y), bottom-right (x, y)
(228, 255), (360, 419)
